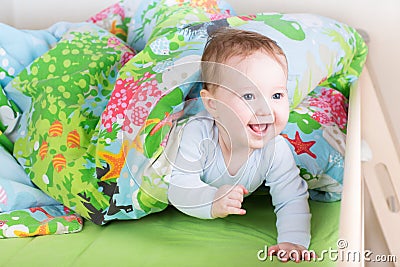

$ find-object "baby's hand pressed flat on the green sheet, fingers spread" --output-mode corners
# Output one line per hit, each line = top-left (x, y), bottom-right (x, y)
(268, 242), (316, 262)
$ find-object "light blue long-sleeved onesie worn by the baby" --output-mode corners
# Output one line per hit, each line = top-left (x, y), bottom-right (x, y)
(168, 112), (311, 248)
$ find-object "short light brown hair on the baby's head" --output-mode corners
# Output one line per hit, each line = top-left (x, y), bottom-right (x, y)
(201, 27), (287, 90)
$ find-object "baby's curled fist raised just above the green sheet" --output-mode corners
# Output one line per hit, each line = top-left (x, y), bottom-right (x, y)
(211, 185), (249, 218)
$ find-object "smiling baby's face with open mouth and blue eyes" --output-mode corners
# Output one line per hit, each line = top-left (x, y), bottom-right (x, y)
(206, 52), (289, 152)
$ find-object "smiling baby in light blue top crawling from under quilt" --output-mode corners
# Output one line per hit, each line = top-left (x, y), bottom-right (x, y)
(168, 28), (311, 261)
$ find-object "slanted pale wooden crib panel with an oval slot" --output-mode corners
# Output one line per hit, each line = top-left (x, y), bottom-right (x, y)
(360, 70), (400, 266)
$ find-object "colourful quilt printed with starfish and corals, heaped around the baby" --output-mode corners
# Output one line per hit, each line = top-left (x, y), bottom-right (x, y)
(0, 0), (367, 237)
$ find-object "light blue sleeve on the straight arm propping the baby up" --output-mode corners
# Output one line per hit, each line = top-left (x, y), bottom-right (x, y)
(265, 136), (311, 248)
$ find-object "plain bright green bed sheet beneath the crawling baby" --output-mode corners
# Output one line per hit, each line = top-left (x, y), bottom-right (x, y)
(0, 195), (340, 267)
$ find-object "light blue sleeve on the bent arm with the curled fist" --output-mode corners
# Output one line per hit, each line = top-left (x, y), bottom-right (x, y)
(168, 117), (217, 219)
